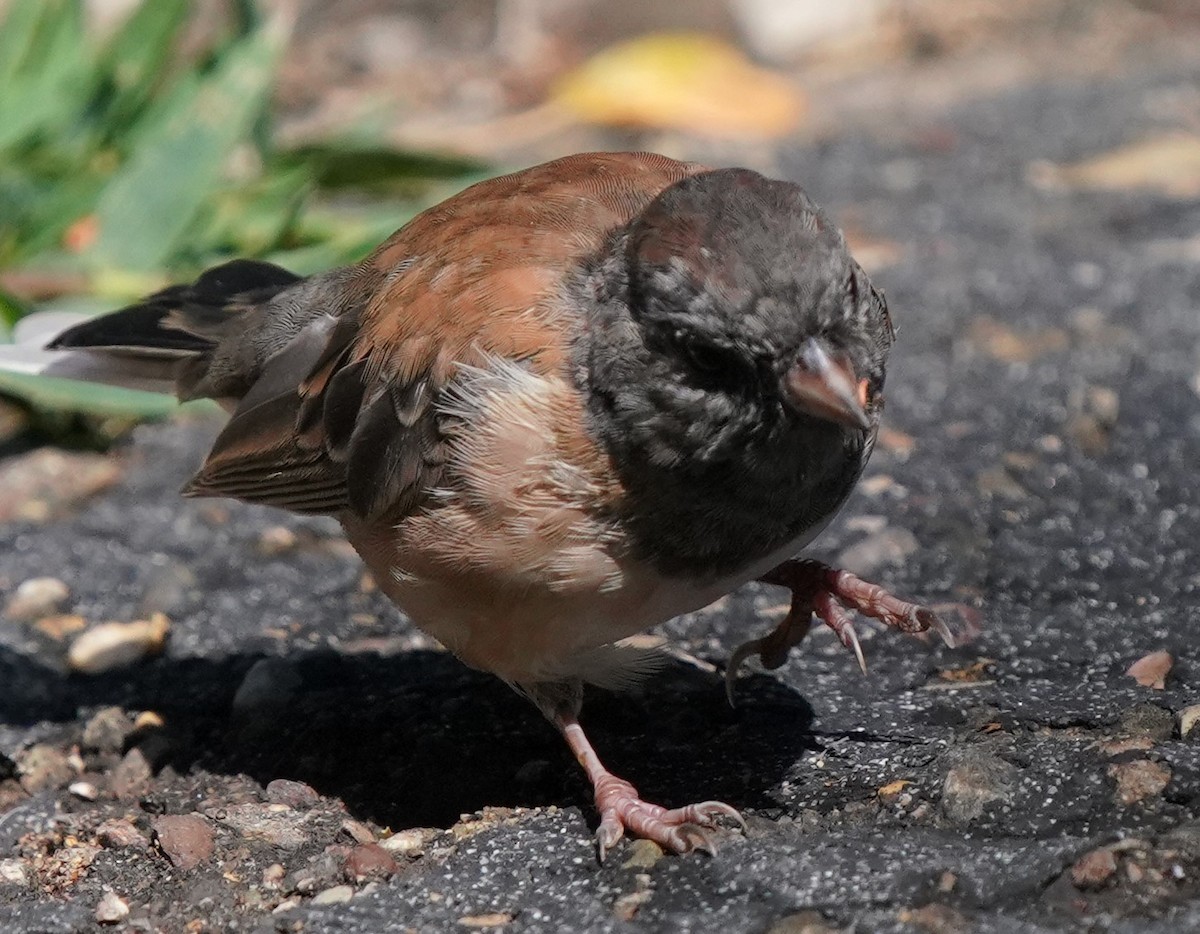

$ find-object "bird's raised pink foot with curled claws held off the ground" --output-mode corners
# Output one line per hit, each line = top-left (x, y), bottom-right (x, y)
(725, 559), (976, 704)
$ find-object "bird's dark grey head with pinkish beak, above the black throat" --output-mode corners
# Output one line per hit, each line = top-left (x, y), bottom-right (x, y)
(625, 169), (893, 444)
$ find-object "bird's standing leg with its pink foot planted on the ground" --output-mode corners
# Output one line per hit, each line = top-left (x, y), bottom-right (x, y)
(522, 682), (745, 861)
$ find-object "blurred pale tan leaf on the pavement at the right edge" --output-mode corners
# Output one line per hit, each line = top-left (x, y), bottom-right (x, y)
(1031, 133), (1200, 198)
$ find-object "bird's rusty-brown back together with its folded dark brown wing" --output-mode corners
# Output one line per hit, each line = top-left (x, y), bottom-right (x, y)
(186, 152), (701, 519)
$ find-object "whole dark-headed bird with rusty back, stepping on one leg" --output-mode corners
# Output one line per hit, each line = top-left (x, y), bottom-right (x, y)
(30, 152), (959, 860)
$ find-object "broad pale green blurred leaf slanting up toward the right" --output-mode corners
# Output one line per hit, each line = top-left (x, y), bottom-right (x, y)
(88, 16), (290, 270)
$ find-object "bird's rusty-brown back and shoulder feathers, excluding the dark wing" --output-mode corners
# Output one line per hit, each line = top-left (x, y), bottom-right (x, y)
(356, 152), (703, 379)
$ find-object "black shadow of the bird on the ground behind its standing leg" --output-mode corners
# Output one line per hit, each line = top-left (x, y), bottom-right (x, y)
(0, 646), (817, 830)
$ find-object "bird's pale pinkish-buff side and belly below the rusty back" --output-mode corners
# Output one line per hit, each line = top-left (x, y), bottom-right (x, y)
(344, 357), (740, 682)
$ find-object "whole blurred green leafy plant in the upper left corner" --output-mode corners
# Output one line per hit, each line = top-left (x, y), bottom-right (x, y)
(0, 0), (482, 414)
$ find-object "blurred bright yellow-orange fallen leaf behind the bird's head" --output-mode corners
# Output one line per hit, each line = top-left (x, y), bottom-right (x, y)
(553, 32), (805, 137)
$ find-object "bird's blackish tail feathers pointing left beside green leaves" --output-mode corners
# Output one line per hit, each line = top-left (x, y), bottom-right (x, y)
(42, 259), (300, 397)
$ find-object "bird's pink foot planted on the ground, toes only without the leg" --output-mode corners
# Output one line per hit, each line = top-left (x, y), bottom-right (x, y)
(595, 772), (745, 861)
